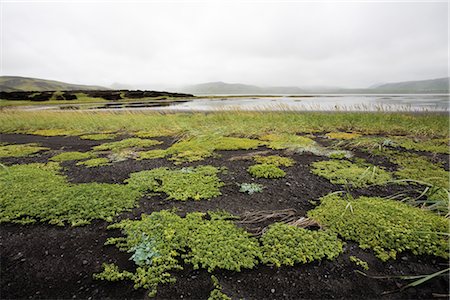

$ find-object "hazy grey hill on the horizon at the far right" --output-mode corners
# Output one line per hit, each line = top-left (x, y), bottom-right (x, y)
(373, 77), (449, 93)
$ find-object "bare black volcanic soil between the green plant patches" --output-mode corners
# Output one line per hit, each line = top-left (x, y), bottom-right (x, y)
(0, 134), (449, 299)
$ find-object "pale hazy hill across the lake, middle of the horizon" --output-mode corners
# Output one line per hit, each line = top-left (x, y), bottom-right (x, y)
(179, 81), (304, 95)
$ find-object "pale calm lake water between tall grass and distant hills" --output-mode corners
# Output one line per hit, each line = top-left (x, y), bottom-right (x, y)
(153, 95), (450, 111)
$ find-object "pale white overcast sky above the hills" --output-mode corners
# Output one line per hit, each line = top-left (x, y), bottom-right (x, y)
(0, 0), (449, 88)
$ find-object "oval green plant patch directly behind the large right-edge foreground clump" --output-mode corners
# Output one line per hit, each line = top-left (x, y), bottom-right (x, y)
(311, 159), (392, 187)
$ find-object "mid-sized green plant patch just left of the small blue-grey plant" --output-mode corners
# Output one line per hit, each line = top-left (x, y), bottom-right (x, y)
(126, 166), (223, 201)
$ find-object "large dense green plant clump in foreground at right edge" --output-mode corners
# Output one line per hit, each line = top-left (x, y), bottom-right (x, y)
(308, 194), (449, 261)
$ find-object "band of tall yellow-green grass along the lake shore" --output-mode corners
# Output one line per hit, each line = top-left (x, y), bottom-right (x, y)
(0, 111), (449, 137)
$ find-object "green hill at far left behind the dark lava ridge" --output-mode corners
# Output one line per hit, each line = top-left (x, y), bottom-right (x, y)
(0, 76), (107, 92)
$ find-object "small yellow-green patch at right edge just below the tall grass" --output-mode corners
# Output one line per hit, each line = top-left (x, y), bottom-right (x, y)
(392, 136), (450, 154)
